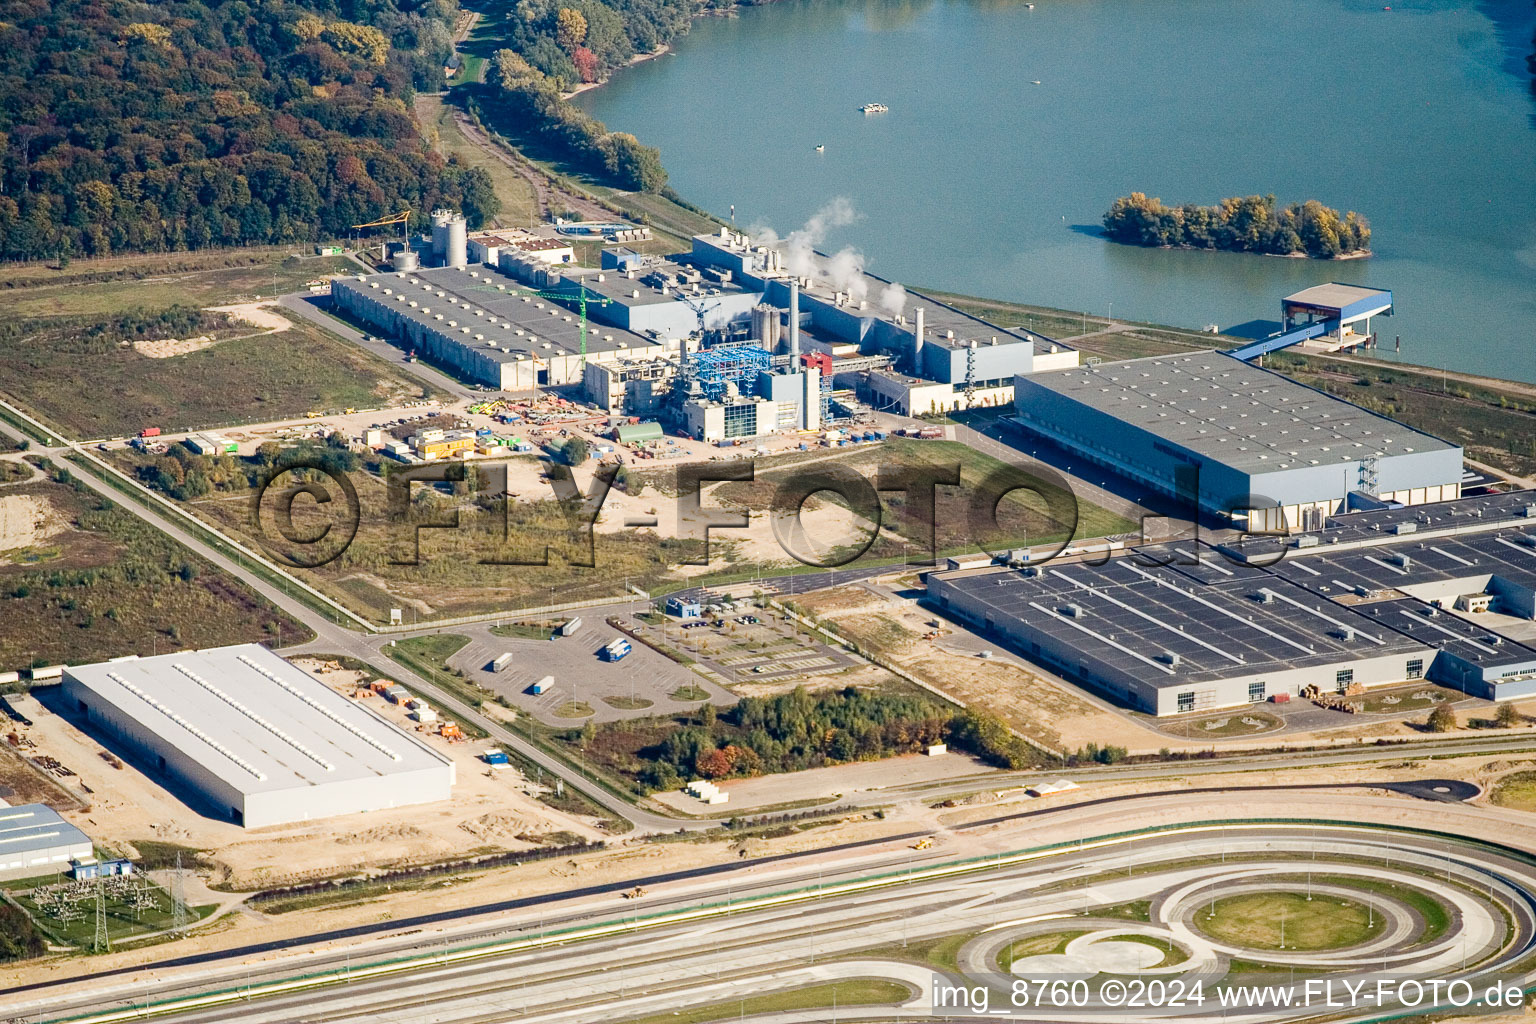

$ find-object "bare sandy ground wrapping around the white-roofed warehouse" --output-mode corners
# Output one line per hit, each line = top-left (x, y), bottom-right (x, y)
(1, 671), (605, 889)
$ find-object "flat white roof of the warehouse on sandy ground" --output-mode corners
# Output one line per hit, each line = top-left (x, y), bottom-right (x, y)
(66, 643), (444, 794)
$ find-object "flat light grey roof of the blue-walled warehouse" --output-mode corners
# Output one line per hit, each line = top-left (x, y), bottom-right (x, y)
(1025, 352), (1456, 473)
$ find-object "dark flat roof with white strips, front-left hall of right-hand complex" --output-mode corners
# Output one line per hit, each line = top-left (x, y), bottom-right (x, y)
(927, 556), (1424, 688)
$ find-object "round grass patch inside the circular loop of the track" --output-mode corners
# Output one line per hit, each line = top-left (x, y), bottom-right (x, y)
(1192, 892), (1387, 950)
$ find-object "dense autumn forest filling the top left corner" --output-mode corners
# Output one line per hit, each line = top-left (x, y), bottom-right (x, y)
(0, 0), (498, 259)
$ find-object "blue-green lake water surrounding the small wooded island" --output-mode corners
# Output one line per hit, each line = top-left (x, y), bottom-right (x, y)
(579, 0), (1536, 381)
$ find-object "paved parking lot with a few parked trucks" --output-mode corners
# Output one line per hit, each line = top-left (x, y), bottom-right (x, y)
(449, 605), (736, 726)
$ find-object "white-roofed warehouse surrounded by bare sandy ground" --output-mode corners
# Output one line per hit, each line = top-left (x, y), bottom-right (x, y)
(63, 643), (453, 827)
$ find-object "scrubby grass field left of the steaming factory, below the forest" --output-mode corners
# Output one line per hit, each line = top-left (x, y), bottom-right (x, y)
(0, 321), (425, 438)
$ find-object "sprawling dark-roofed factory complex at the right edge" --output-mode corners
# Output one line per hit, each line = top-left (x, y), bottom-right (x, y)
(928, 491), (1536, 715)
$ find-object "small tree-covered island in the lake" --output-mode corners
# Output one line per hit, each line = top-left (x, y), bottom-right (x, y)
(1104, 192), (1370, 259)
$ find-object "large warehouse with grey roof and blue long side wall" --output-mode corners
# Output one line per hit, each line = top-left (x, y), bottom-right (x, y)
(1014, 352), (1462, 531)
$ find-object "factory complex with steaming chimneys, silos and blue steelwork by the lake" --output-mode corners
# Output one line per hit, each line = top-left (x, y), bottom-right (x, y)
(332, 224), (1078, 441)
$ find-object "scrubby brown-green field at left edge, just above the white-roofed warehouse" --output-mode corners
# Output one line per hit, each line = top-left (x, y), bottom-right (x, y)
(0, 481), (309, 668)
